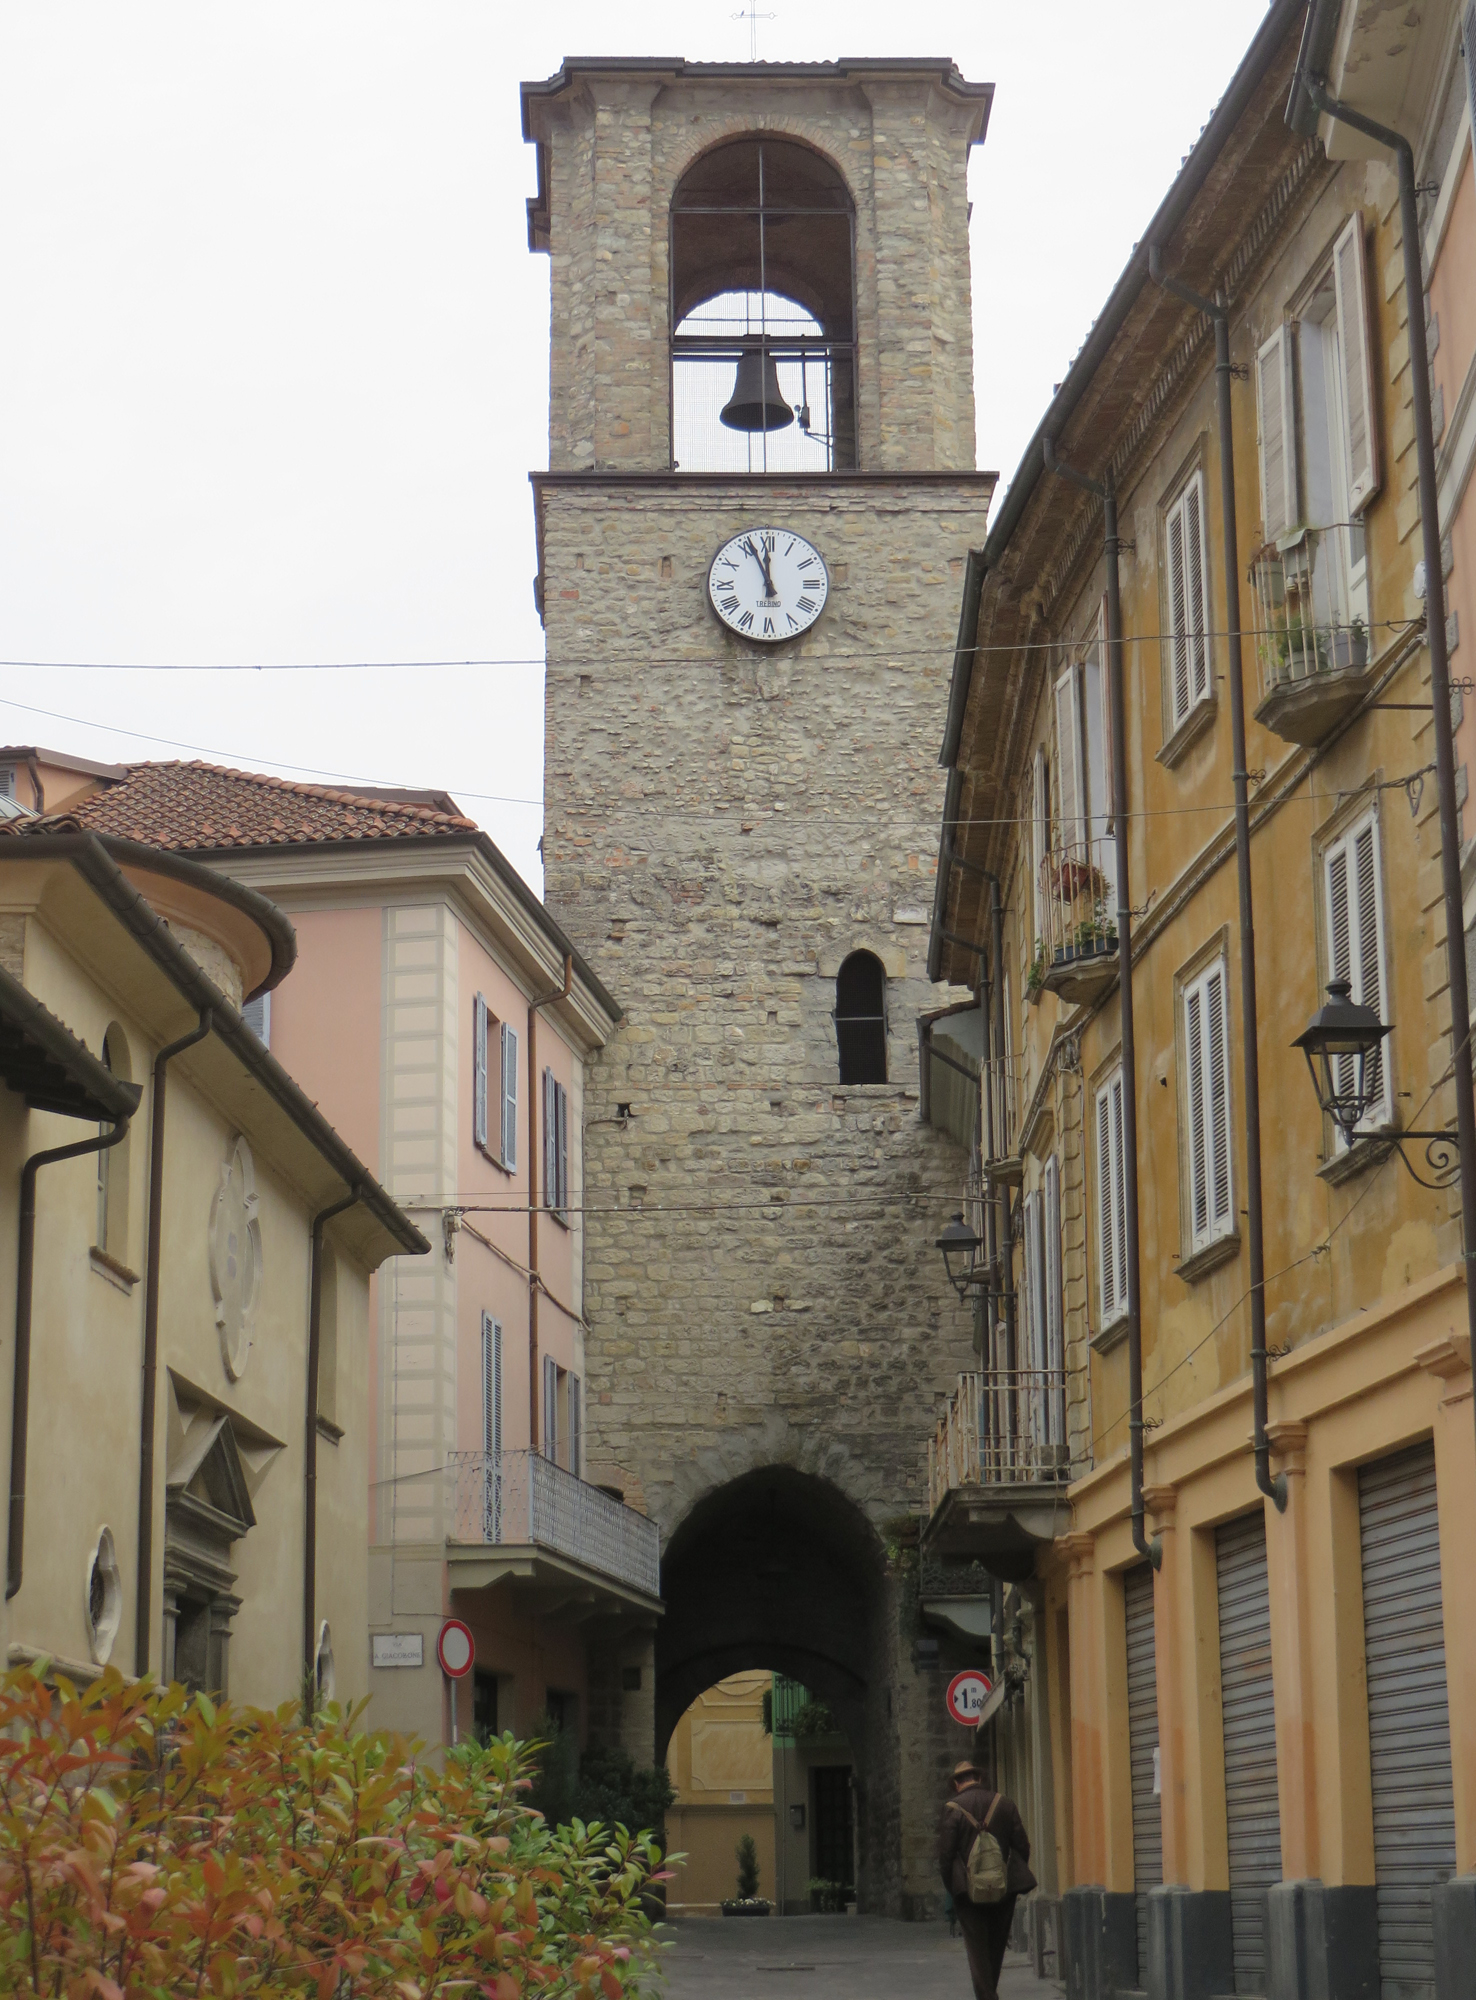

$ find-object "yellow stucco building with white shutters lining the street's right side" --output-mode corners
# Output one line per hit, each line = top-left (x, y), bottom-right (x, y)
(924, 4), (1476, 2000)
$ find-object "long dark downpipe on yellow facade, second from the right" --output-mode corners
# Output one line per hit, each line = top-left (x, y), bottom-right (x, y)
(1148, 244), (1286, 1512)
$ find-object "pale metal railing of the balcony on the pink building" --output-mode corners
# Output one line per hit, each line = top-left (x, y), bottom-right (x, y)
(446, 1452), (662, 1598)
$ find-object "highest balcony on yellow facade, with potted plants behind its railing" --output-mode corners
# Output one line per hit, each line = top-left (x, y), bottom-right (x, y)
(1250, 526), (1368, 744)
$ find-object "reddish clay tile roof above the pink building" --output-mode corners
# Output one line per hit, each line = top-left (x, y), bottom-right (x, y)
(32, 762), (476, 852)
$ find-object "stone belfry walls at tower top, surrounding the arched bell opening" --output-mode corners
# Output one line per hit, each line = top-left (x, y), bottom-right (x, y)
(530, 68), (980, 472)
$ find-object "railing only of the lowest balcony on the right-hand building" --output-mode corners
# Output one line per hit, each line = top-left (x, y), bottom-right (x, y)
(928, 1368), (1086, 1512)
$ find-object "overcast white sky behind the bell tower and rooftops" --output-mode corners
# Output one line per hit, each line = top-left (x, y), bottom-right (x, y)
(0, 0), (1264, 886)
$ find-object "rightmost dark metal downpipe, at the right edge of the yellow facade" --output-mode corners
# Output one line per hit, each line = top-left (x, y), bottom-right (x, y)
(1304, 76), (1476, 1488)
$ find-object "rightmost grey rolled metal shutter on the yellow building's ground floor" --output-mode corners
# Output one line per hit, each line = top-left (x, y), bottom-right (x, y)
(1358, 1444), (1456, 2000)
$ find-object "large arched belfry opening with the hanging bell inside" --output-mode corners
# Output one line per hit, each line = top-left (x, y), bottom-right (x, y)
(670, 138), (856, 472)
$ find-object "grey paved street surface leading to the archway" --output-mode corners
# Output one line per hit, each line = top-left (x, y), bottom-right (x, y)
(664, 1916), (1060, 2000)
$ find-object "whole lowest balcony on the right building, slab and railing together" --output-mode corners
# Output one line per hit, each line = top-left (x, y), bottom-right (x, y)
(924, 1368), (1088, 1578)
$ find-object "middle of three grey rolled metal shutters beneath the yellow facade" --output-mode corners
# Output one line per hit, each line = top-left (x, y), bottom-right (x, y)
(1214, 1508), (1282, 1994)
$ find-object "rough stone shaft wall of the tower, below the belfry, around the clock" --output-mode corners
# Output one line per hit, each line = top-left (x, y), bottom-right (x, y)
(544, 476), (990, 1910)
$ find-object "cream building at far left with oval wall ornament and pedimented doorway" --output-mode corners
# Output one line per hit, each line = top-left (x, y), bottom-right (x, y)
(0, 828), (428, 1704)
